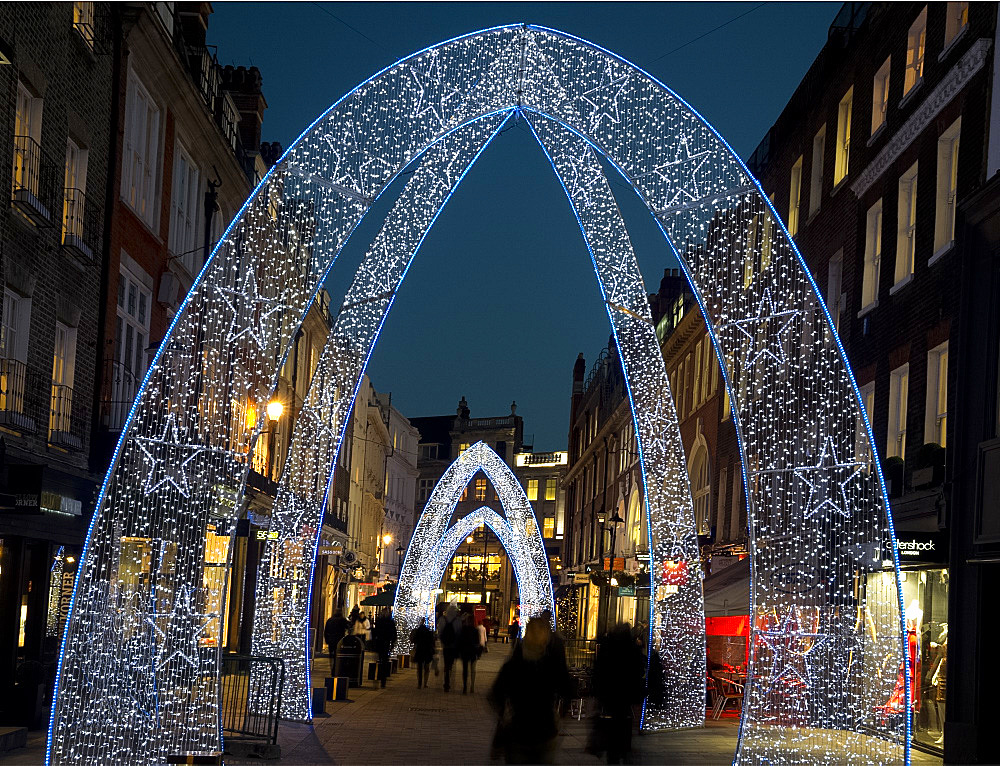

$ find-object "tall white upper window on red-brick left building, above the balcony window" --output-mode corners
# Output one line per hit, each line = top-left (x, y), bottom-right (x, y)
(122, 70), (160, 229)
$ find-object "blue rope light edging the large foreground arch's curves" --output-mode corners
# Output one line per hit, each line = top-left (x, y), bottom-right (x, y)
(45, 23), (912, 766)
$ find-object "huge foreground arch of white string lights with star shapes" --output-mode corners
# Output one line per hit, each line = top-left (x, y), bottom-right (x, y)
(47, 25), (910, 764)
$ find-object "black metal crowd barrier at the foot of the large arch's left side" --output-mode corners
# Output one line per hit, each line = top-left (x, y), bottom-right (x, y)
(219, 654), (285, 750)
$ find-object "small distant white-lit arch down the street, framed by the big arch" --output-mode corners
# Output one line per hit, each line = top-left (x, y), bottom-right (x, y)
(393, 442), (555, 651)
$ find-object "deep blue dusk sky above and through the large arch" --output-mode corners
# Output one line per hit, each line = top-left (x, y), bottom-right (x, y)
(208, 2), (839, 450)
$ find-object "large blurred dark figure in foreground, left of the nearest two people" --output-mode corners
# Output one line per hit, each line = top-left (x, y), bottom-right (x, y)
(489, 617), (572, 763)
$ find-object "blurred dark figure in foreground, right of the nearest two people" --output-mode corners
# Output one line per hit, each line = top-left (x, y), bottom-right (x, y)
(592, 622), (646, 763)
